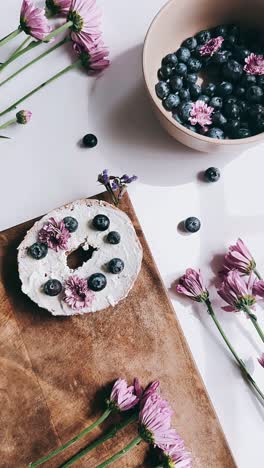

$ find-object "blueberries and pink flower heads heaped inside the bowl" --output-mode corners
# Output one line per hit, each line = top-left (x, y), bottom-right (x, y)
(156, 25), (264, 139)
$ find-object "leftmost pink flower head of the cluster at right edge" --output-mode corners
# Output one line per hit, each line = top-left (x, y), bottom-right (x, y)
(176, 268), (209, 302)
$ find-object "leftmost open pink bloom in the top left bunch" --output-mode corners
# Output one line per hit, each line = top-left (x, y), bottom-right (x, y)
(20, 0), (51, 41)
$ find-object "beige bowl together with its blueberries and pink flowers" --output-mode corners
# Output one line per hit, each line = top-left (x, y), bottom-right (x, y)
(143, 0), (264, 152)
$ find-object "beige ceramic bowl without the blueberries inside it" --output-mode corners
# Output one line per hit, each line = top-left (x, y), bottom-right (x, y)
(143, 0), (264, 152)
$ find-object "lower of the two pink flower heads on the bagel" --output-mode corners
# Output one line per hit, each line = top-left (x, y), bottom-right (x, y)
(63, 276), (95, 310)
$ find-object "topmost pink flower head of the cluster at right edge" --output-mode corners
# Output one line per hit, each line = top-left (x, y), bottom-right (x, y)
(224, 239), (256, 275)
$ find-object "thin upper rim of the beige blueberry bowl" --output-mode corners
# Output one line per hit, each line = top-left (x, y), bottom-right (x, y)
(142, 0), (264, 146)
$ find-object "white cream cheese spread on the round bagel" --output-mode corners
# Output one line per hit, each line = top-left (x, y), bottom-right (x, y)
(18, 199), (142, 315)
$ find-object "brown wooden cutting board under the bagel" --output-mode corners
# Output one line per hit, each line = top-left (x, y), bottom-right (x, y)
(0, 193), (235, 468)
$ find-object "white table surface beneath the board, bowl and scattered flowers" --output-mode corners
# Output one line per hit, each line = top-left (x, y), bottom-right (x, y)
(0, 0), (264, 468)
